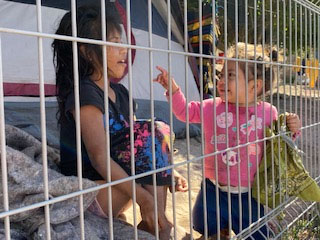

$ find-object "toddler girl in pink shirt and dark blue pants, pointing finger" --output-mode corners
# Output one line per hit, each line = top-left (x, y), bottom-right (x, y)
(155, 44), (300, 239)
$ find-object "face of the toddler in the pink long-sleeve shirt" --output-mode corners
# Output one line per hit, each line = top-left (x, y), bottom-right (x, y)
(217, 61), (255, 106)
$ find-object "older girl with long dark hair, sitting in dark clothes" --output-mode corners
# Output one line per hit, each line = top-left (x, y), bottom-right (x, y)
(52, 6), (188, 239)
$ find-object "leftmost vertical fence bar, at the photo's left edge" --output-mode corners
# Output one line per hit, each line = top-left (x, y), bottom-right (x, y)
(0, 34), (11, 240)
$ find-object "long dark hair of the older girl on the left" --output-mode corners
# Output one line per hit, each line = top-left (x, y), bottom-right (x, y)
(52, 6), (121, 123)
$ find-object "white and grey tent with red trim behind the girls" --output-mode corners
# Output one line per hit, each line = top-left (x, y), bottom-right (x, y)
(0, 0), (200, 141)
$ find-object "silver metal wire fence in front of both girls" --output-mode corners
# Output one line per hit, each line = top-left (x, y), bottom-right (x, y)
(0, 0), (320, 239)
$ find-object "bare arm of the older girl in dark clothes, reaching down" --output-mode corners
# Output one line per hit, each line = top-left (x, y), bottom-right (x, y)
(73, 105), (163, 230)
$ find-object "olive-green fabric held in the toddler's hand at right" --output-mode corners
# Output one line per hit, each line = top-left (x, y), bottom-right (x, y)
(252, 114), (320, 208)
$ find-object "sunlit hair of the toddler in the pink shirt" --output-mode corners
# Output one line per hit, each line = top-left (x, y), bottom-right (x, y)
(227, 42), (278, 97)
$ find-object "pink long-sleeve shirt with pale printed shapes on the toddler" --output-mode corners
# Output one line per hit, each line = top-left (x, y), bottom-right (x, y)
(172, 90), (278, 187)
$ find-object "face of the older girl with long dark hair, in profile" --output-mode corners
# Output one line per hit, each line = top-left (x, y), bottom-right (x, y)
(107, 30), (128, 78)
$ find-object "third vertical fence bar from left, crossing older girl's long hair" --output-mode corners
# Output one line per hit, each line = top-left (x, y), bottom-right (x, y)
(71, 0), (85, 240)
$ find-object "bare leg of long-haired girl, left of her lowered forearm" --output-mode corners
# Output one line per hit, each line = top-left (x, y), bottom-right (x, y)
(96, 180), (132, 218)
